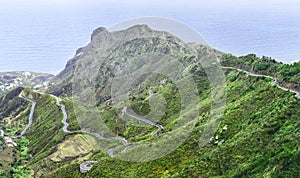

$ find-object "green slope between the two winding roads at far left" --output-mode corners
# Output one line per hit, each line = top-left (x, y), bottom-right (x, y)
(11, 89), (64, 176)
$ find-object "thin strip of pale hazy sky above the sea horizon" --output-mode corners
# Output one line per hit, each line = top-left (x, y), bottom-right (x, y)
(0, 0), (300, 9)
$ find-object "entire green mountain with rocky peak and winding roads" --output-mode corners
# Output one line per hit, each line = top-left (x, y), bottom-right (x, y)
(0, 25), (300, 177)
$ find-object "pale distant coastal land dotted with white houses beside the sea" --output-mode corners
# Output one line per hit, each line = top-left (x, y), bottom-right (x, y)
(0, 71), (54, 93)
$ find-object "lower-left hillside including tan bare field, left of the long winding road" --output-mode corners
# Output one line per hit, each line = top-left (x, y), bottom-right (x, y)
(0, 88), (97, 177)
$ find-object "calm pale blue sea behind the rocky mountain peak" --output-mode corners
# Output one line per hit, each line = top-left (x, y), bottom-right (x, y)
(0, 3), (300, 74)
